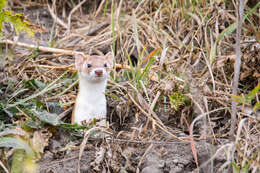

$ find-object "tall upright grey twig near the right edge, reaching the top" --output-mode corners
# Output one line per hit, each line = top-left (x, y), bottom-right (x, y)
(229, 0), (244, 140)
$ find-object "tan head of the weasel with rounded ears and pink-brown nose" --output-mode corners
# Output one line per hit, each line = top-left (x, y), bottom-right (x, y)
(75, 52), (113, 83)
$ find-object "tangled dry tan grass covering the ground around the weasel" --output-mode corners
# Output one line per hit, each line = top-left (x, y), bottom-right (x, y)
(0, 0), (260, 172)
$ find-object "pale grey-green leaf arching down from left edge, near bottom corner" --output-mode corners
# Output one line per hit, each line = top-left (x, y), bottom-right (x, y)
(0, 137), (34, 156)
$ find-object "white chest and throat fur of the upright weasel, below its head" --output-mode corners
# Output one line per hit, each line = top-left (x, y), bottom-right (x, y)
(74, 78), (107, 125)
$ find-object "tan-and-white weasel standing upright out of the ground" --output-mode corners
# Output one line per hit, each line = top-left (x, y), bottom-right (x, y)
(71, 53), (113, 125)
